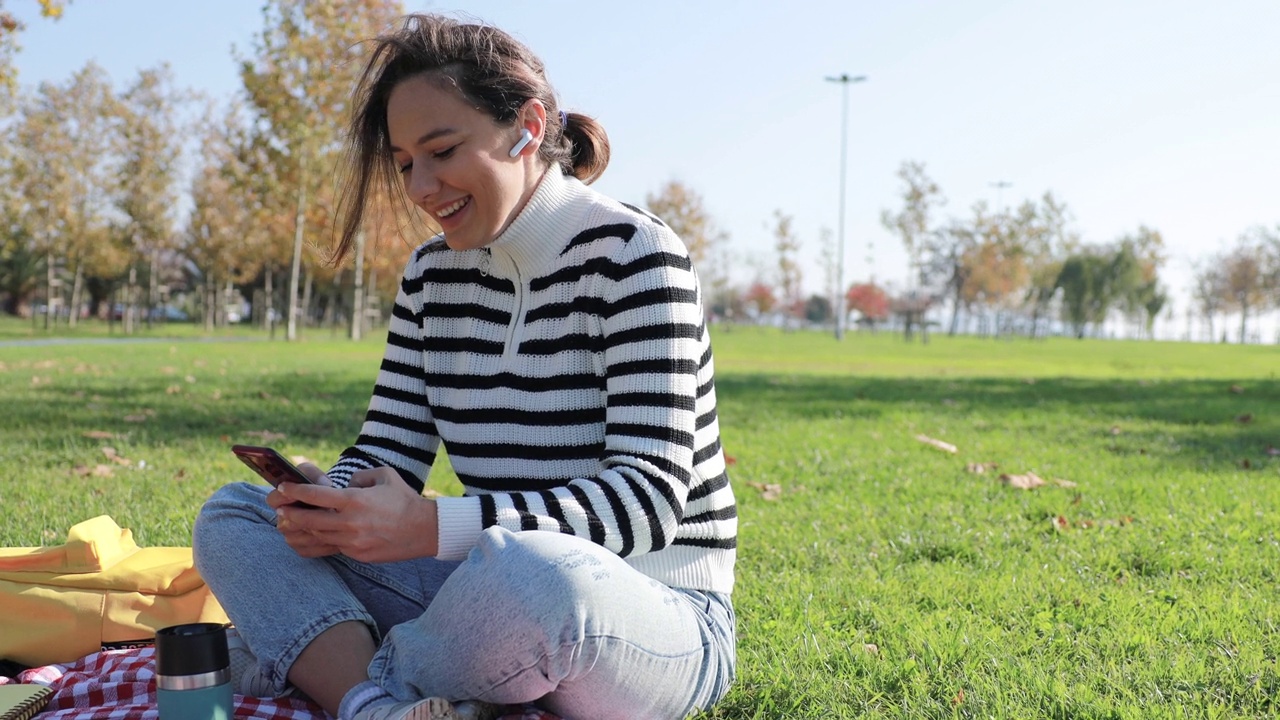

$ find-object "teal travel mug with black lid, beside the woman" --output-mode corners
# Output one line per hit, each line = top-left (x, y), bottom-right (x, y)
(156, 623), (234, 720)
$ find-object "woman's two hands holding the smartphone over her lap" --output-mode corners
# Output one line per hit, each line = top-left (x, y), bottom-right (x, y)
(268, 462), (438, 562)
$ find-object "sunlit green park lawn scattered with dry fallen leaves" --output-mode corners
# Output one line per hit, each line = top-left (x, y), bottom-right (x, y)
(0, 328), (1280, 720)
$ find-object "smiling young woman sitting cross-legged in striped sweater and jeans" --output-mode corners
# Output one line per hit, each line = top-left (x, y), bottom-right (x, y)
(195, 15), (737, 720)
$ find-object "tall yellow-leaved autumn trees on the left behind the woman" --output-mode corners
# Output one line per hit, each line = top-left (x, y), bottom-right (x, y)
(0, 0), (412, 340)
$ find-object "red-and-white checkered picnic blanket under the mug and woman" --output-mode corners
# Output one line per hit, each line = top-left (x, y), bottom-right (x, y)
(0, 647), (557, 720)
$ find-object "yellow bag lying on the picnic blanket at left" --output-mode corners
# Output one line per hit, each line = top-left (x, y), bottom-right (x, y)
(0, 515), (227, 666)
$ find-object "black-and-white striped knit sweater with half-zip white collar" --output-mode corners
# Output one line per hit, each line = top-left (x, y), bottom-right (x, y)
(329, 168), (737, 592)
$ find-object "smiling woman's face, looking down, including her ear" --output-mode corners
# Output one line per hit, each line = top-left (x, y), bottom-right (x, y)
(387, 77), (541, 250)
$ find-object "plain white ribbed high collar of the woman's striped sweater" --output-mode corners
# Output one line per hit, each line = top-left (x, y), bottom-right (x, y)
(485, 165), (588, 278)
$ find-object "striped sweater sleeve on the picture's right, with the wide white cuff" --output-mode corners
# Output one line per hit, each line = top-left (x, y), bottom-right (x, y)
(453, 224), (705, 557)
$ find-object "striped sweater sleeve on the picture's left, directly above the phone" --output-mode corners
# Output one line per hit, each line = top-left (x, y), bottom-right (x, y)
(328, 251), (440, 492)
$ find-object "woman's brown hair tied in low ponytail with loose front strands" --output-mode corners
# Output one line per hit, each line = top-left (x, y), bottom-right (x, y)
(333, 14), (609, 264)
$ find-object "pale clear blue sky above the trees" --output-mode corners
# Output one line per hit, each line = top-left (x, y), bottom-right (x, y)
(6, 0), (1280, 324)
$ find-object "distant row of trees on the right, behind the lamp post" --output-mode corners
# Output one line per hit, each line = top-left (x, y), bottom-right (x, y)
(648, 160), (1280, 342)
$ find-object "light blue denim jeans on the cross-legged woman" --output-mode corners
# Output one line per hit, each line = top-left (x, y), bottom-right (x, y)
(193, 483), (736, 720)
